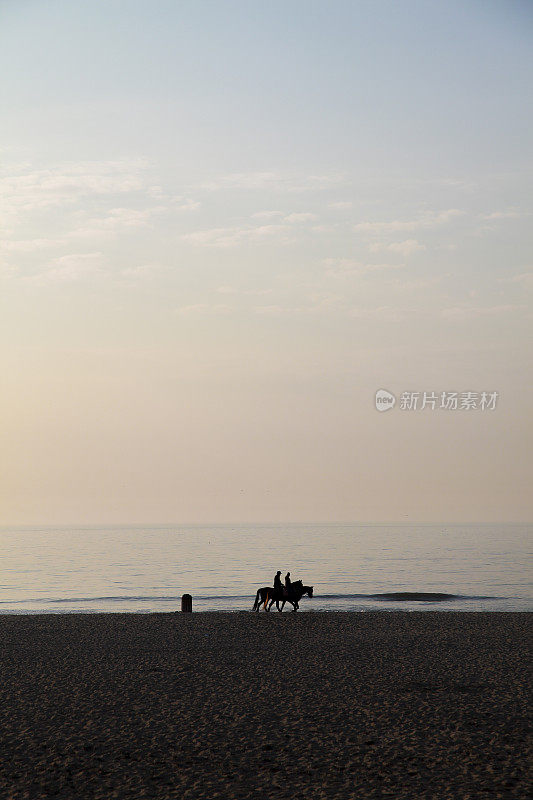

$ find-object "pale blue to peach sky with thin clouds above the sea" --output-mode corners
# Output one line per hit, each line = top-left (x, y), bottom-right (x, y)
(0, 0), (533, 525)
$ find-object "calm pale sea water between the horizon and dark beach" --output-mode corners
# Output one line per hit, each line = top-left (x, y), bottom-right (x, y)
(0, 524), (533, 613)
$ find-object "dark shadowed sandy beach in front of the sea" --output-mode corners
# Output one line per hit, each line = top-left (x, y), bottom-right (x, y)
(0, 612), (532, 800)
